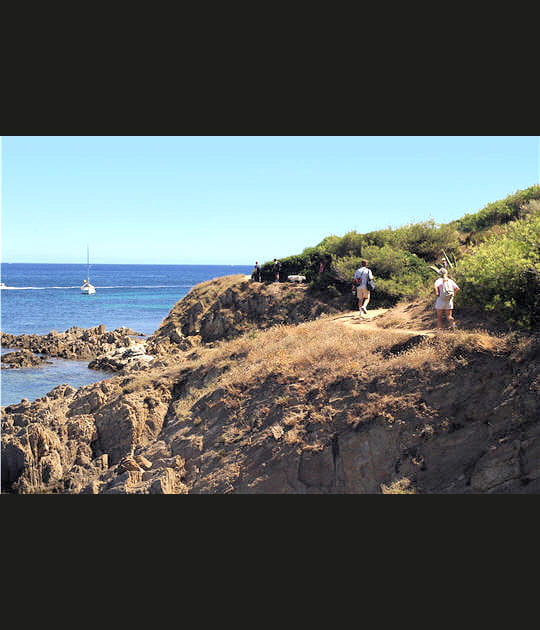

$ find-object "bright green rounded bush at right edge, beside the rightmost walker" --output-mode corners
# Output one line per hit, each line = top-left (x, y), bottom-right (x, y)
(455, 216), (540, 330)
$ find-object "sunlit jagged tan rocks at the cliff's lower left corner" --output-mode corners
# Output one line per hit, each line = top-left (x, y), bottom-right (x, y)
(2, 377), (177, 493)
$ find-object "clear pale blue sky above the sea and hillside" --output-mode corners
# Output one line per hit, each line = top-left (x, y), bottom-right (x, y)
(1, 136), (540, 265)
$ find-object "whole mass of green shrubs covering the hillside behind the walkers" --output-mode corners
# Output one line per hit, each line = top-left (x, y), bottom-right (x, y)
(262, 185), (540, 328)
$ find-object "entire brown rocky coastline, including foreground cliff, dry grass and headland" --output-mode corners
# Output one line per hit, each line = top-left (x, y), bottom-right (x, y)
(2, 276), (540, 494)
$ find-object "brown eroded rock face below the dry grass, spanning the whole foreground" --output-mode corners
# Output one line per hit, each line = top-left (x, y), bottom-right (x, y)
(2, 339), (540, 494)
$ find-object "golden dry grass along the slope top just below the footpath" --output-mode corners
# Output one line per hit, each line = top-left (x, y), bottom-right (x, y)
(159, 316), (508, 407)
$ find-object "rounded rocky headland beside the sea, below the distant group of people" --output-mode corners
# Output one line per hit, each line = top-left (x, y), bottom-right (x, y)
(147, 275), (343, 354)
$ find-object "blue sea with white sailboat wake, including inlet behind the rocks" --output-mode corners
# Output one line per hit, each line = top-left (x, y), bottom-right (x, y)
(0, 263), (253, 405)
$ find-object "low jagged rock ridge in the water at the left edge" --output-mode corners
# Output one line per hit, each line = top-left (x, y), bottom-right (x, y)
(0, 324), (144, 360)
